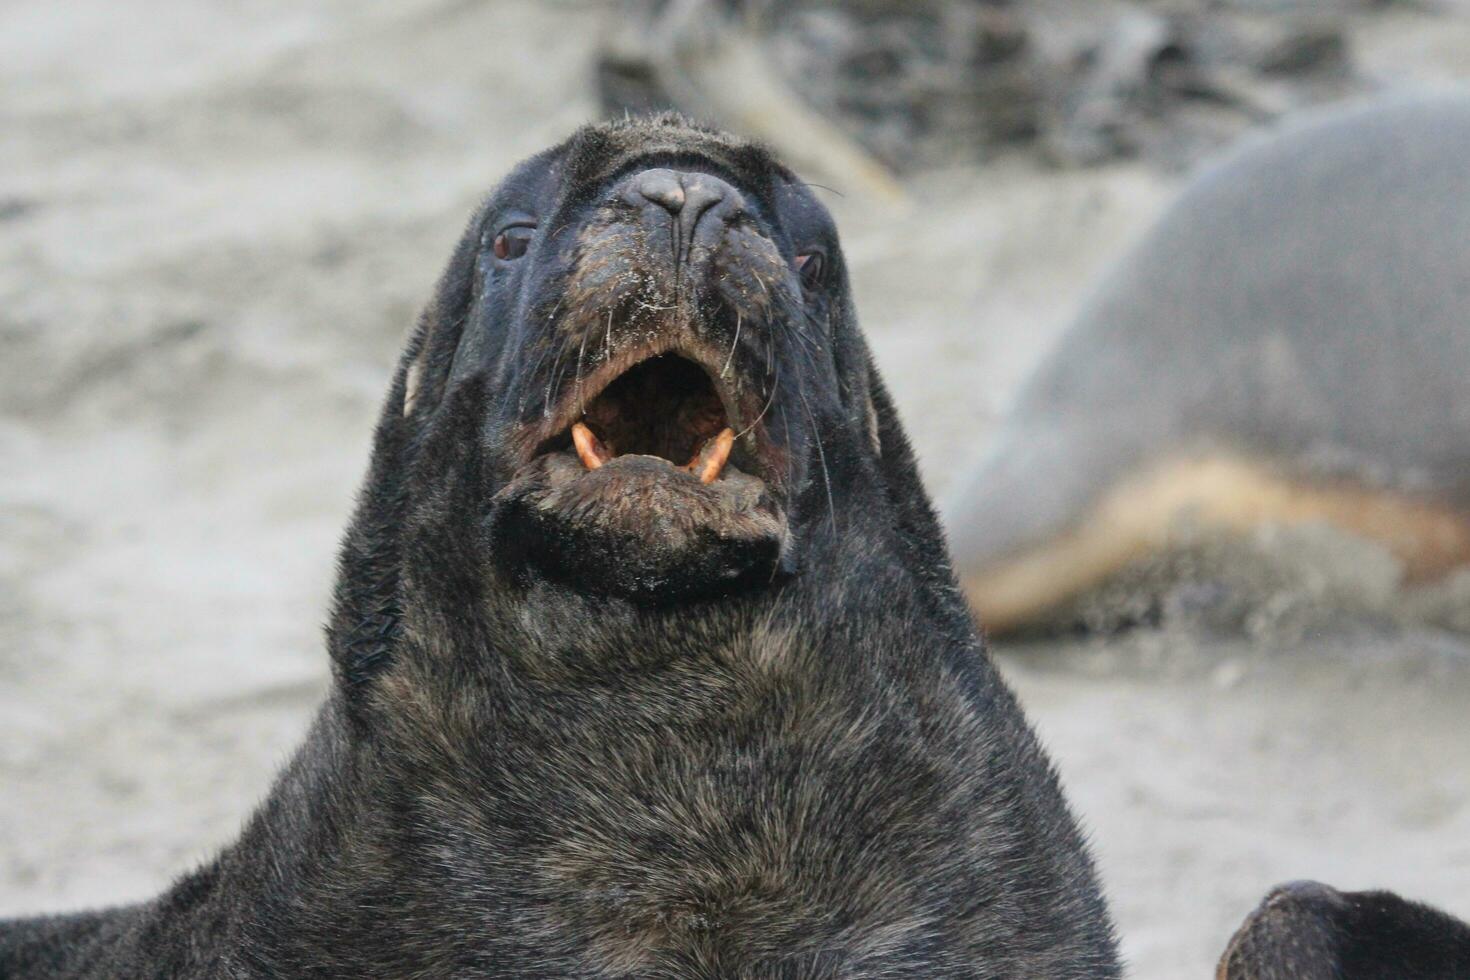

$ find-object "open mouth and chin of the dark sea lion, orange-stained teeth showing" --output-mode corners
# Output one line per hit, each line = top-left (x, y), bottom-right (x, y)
(494, 337), (788, 601)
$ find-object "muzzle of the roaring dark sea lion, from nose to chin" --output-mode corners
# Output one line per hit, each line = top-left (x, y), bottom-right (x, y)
(491, 159), (804, 601)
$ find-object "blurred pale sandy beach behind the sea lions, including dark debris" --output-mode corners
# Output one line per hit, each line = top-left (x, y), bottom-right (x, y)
(0, 0), (1470, 977)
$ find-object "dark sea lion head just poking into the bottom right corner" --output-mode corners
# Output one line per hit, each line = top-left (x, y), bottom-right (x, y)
(1216, 882), (1470, 980)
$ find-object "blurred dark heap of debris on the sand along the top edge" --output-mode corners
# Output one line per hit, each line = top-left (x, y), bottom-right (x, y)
(597, 0), (1391, 169)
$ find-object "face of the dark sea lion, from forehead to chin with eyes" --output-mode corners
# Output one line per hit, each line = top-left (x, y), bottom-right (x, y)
(402, 119), (869, 604)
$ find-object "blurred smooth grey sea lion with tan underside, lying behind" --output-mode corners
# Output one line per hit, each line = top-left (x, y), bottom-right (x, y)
(945, 93), (1470, 630)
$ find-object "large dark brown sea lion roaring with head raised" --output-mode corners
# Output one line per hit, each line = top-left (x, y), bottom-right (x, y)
(0, 118), (1119, 980)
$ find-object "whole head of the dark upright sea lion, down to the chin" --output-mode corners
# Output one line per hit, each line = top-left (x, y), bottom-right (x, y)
(340, 116), (928, 681)
